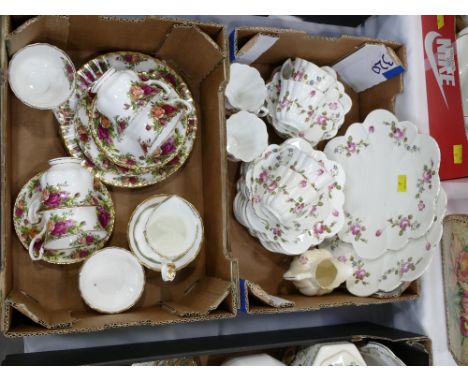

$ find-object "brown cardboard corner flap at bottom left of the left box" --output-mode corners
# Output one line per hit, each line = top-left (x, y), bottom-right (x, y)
(5, 290), (75, 329)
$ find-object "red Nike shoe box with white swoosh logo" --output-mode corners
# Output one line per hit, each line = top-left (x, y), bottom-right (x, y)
(421, 16), (468, 180)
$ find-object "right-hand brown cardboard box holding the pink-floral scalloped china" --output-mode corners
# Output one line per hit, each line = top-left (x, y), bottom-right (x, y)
(228, 28), (419, 314)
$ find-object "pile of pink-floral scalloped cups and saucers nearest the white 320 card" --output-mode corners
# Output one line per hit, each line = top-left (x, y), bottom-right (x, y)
(267, 58), (351, 146)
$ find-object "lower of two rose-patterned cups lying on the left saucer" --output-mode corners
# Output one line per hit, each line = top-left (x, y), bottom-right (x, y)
(29, 206), (107, 260)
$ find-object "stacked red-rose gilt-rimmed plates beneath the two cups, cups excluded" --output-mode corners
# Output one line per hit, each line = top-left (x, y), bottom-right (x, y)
(54, 52), (197, 187)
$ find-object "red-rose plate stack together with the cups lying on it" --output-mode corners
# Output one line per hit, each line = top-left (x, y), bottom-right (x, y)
(54, 52), (197, 187)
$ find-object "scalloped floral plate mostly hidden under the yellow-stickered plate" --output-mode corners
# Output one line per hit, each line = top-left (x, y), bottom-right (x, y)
(320, 188), (447, 297)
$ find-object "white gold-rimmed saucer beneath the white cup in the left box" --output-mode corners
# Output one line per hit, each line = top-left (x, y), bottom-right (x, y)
(127, 194), (204, 272)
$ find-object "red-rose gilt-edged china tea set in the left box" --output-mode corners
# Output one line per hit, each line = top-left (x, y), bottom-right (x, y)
(9, 44), (204, 313)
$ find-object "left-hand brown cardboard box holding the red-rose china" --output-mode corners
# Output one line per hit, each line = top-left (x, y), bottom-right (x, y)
(0, 16), (237, 336)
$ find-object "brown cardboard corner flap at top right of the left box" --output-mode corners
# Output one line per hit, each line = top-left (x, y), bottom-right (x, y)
(157, 24), (225, 83)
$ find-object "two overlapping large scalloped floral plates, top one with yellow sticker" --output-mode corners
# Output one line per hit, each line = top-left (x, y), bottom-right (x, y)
(321, 110), (447, 296)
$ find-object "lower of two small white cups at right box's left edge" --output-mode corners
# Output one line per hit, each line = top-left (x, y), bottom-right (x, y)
(226, 111), (268, 162)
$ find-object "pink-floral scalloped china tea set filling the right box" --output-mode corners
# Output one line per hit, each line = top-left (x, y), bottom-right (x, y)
(226, 58), (447, 297)
